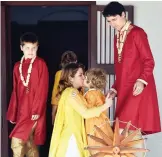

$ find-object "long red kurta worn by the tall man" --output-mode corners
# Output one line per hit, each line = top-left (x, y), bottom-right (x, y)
(112, 26), (161, 133)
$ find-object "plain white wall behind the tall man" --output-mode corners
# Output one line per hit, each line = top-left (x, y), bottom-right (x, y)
(97, 1), (162, 157)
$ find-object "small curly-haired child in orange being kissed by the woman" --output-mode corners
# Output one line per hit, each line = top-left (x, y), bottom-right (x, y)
(84, 68), (113, 153)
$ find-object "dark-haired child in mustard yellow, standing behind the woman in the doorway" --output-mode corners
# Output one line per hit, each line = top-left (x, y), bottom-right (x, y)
(51, 51), (77, 124)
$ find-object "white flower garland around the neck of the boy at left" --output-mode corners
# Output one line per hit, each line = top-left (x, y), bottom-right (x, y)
(19, 56), (36, 87)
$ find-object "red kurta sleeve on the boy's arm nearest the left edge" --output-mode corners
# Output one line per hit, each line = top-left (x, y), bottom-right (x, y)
(7, 65), (18, 122)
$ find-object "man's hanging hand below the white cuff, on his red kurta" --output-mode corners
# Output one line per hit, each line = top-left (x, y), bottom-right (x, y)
(133, 81), (145, 96)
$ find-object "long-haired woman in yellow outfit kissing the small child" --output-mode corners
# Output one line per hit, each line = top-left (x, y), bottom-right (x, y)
(49, 63), (112, 157)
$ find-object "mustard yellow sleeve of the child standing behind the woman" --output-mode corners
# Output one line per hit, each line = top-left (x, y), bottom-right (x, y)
(51, 70), (61, 105)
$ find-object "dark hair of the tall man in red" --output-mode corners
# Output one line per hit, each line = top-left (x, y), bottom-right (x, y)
(102, 1), (125, 17)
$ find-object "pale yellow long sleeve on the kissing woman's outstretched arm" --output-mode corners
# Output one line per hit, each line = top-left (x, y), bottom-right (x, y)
(68, 93), (112, 119)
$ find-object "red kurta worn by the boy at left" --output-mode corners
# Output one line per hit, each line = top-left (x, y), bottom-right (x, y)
(7, 57), (48, 145)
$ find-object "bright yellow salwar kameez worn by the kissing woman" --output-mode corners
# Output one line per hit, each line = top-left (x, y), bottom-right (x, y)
(49, 88), (110, 157)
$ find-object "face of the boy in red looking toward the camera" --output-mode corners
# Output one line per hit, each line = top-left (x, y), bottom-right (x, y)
(20, 42), (38, 59)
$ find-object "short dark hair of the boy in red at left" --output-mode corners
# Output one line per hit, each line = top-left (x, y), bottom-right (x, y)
(20, 32), (38, 46)
